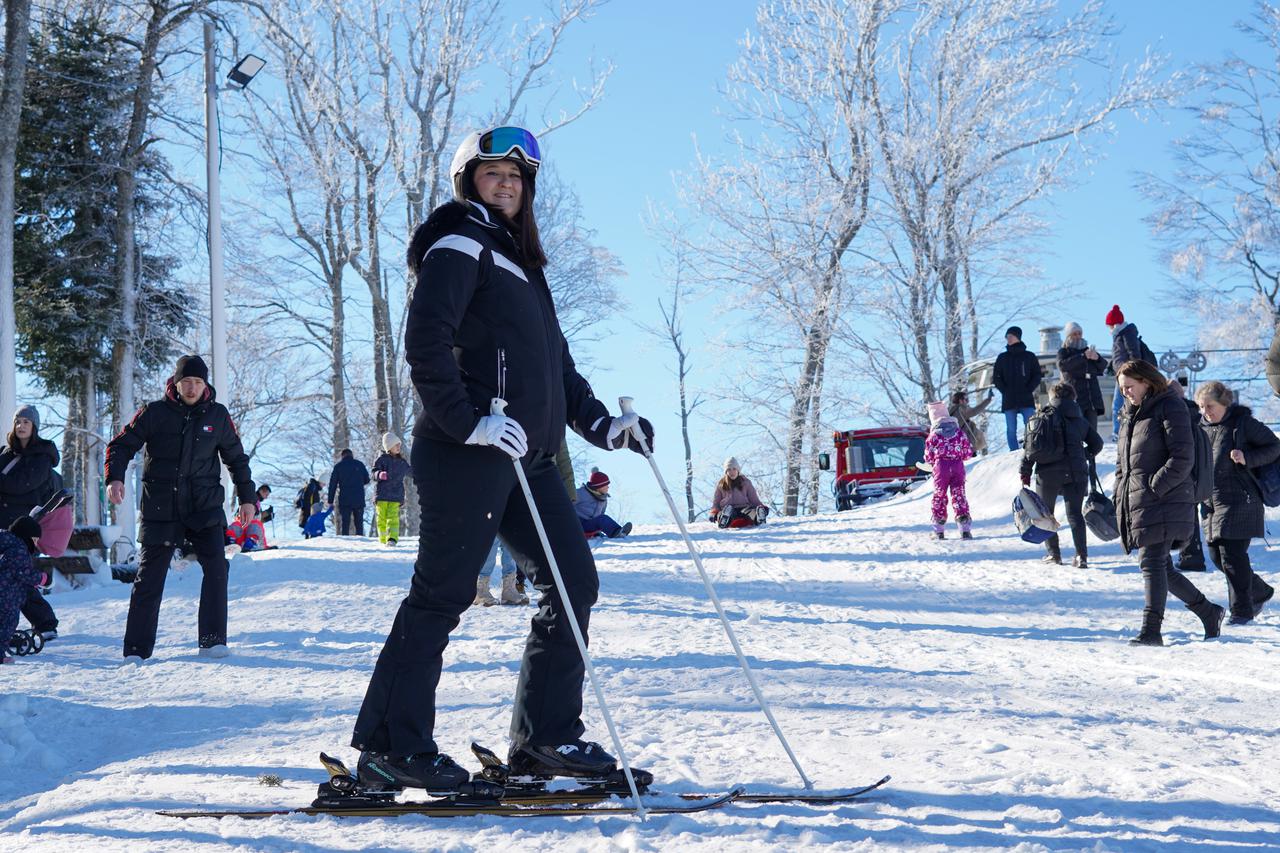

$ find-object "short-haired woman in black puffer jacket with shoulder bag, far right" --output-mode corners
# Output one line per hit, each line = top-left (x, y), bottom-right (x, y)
(1196, 382), (1280, 625)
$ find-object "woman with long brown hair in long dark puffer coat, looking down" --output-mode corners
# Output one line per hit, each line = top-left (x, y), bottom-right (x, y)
(1115, 360), (1226, 646)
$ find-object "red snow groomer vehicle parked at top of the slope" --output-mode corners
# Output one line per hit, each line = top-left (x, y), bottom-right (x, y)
(818, 427), (929, 510)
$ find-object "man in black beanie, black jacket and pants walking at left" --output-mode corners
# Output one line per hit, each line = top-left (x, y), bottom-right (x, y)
(106, 356), (257, 662)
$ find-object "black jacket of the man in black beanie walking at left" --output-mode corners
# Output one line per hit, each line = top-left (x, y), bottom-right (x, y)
(105, 379), (257, 546)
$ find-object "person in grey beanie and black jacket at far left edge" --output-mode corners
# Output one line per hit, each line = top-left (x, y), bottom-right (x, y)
(0, 406), (61, 643)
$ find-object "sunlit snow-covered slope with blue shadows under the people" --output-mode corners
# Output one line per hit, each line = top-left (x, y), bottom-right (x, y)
(0, 455), (1280, 852)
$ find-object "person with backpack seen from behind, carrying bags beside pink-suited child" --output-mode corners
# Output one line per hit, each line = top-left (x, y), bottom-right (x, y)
(1019, 380), (1102, 569)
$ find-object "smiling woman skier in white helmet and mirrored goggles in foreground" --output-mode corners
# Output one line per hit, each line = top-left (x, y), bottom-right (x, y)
(351, 127), (653, 790)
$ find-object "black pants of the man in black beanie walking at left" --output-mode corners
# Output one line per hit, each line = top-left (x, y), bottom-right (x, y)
(124, 525), (227, 658)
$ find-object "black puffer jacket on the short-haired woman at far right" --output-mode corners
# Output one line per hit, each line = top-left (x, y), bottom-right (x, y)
(1201, 406), (1280, 543)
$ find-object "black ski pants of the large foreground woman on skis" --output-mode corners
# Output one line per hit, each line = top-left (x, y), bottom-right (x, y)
(351, 439), (599, 756)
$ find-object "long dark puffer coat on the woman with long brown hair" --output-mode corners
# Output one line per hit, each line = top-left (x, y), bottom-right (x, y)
(1115, 388), (1196, 553)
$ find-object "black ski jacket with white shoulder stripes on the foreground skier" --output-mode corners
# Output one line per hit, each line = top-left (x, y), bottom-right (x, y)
(404, 201), (609, 456)
